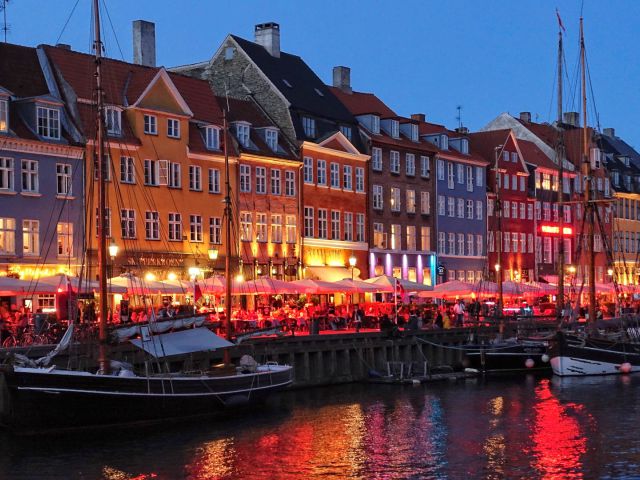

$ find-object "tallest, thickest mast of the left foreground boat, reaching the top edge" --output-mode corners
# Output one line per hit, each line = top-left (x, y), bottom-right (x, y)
(93, 0), (109, 374)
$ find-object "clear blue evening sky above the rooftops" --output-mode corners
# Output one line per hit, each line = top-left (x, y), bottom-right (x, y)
(7, 0), (640, 148)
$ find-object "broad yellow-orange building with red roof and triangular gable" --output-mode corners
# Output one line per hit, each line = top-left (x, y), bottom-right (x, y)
(45, 47), (236, 278)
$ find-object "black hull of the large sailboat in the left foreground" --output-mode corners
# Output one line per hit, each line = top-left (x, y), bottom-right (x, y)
(0, 365), (293, 434)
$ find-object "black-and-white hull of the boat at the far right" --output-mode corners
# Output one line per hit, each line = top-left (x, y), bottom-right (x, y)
(549, 332), (640, 376)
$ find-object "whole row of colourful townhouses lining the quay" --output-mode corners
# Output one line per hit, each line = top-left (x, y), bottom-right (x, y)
(0, 21), (640, 298)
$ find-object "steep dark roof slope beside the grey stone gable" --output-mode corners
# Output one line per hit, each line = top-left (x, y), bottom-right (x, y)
(230, 35), (354, 123)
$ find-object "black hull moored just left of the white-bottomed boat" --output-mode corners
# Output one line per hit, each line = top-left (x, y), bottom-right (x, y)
(465, 341), (551, 374)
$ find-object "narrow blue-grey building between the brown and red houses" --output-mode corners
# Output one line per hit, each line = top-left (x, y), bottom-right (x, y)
(420, 123), (488, 283)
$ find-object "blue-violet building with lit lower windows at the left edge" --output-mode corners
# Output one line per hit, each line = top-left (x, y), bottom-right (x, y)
(0, 43), (84, 298)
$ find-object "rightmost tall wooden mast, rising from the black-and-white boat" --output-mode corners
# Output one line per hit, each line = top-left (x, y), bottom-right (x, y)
(580, 17), (596, 329)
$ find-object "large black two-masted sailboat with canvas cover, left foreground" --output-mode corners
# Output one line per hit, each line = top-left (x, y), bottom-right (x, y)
(0, 0), (293, 434)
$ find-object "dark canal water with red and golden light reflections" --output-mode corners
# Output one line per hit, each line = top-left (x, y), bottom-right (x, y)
(0, 375), (640, 480)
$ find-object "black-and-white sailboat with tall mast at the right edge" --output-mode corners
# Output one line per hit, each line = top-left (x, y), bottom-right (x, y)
(549, 18), (640, 376)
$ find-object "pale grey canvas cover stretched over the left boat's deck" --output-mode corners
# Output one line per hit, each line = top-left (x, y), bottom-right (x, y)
(130, 327), (233, 358)
